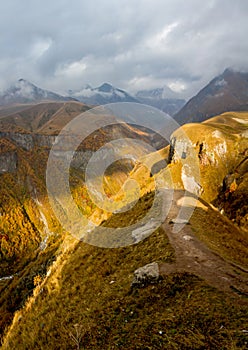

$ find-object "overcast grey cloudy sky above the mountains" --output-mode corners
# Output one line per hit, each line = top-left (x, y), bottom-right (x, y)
(0, 0), (248, 98)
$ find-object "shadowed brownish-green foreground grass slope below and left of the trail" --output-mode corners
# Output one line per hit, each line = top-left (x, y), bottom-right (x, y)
(3, 196), (248, 350)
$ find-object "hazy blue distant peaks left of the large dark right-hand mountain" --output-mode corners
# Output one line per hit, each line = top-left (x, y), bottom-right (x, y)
(0, 79), (186, 115)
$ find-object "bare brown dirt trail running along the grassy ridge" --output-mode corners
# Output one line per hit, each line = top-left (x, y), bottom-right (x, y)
(159, 191), (248, 296)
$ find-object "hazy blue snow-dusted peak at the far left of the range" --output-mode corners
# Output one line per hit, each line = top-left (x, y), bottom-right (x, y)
(0, 79), (75, 105)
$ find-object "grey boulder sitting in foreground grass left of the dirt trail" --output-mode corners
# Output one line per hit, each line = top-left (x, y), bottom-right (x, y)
(131, 262), (161, 287)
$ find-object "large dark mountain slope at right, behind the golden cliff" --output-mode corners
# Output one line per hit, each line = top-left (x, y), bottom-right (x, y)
(174, 69), (248, 124)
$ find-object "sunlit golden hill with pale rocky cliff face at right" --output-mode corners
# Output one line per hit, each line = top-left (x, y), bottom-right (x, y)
(169, 113), (248, 201)
